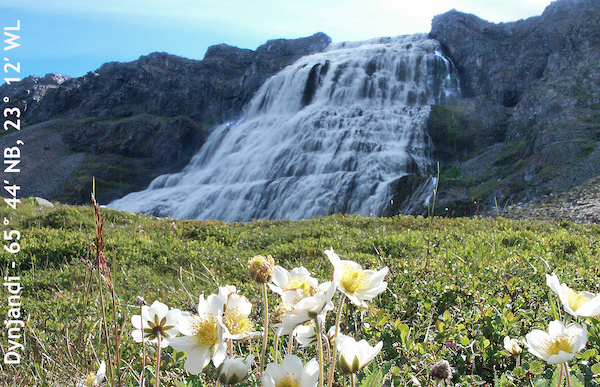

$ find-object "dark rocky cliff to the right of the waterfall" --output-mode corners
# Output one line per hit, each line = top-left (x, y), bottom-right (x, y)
(428, 0), (600, 213)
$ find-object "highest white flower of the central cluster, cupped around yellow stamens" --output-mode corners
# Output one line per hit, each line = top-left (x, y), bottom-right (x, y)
(325, 249), (389, 307)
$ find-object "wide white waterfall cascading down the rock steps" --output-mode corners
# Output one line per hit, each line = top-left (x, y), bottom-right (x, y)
(109, 34), (458, 221)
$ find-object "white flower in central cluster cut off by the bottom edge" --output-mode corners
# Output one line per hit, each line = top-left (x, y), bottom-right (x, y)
(262, 355), (319, 387)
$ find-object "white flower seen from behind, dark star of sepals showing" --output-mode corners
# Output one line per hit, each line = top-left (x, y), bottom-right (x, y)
(131, 301), (187, 348)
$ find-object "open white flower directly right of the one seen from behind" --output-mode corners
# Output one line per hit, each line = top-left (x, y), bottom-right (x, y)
(171, 294), (227, 375)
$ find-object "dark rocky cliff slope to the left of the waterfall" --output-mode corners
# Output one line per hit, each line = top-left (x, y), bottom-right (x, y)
(0, 33), (331, 203)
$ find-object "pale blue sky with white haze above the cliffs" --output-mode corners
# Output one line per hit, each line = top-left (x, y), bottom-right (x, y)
(0, 0), (551, 78)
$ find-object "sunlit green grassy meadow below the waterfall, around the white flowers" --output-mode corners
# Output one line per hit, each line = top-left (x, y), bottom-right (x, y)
(0, 200), (600, 387)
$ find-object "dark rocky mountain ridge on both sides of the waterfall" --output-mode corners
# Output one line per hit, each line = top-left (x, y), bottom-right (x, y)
(0, 0), (600, 221)
